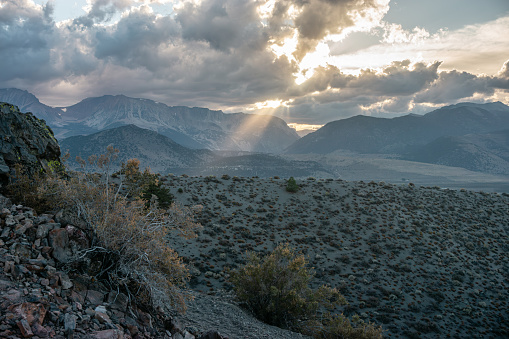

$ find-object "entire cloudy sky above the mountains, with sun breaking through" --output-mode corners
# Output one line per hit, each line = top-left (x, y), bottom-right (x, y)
(0, 0), (509, 128)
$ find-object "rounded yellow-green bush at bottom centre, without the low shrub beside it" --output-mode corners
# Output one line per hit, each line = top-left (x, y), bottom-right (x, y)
(231, 245), (346, 330)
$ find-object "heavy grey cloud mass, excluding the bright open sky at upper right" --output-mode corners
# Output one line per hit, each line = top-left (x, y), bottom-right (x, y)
(0, 0), (509, 123)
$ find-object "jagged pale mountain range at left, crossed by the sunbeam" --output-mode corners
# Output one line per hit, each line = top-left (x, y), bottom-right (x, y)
(0, 89), (299, 153)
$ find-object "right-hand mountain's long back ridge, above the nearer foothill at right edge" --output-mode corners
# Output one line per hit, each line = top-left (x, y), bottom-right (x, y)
(286, 102), (509, 155)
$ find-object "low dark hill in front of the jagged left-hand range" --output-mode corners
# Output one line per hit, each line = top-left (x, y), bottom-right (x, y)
(60, 125), (332, 177)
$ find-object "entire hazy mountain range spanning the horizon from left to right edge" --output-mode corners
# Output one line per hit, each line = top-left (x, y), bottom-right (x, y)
(0, 89), (509, 175)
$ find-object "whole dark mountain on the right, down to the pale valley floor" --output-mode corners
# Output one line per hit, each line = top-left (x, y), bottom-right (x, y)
(285, 102), (509, 175)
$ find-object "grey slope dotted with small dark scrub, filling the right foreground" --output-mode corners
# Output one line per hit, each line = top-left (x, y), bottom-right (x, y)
(163, 176), (509, 338)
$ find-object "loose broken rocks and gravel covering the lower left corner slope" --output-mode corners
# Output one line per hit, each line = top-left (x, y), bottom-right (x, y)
(0, 191), (302, 339)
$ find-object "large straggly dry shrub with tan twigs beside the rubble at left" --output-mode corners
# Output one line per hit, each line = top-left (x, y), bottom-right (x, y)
(39, 147), (200, 311)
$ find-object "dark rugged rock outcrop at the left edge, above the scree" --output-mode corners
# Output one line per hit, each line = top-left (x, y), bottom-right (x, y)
(0, 102), (60, 186)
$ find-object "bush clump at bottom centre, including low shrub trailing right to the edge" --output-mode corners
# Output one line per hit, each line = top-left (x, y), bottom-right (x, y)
(231, 244), (382, 339)
